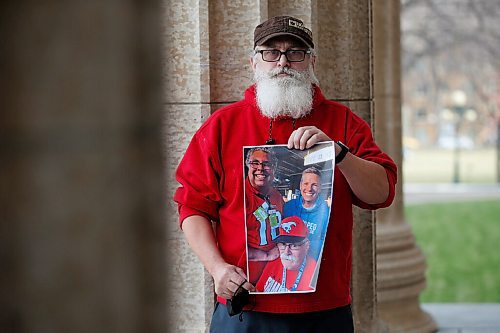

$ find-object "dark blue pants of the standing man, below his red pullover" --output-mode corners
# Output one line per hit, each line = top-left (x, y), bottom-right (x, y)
(210, 303), (354, 333)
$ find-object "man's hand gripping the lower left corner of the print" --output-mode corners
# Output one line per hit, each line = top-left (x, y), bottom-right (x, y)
(212, 263), (255, 299)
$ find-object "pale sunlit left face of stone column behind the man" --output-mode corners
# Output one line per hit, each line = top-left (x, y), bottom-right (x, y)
(162, 1), (213, 332)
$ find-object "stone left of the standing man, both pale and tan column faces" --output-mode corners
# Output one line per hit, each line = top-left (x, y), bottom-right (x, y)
(163, 0), (267, 332)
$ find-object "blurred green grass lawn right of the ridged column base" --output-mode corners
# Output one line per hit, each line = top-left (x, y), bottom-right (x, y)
(405, 200), (500, 303)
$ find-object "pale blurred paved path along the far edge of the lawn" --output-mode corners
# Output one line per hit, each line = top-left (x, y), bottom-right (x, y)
(403, 184), (500, 205)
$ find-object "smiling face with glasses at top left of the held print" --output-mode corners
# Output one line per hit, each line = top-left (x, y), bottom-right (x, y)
(248, 150), (274, 192)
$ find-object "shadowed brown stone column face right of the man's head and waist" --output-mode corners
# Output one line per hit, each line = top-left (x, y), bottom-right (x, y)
(313, 0), (380, 332)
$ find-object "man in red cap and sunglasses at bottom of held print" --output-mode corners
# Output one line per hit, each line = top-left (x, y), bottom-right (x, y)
(255, 216), (316, 293)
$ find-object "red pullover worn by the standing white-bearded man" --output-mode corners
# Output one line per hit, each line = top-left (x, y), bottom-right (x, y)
(174, 86), (397, 313)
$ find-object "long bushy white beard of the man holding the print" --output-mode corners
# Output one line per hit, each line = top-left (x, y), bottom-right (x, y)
(254, 66), (318, 119)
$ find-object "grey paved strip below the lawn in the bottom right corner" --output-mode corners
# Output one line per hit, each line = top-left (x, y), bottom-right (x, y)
(422, 303), (500, 333)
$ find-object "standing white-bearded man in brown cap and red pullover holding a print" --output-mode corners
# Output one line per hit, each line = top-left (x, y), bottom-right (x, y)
(174, 16), (397, 332)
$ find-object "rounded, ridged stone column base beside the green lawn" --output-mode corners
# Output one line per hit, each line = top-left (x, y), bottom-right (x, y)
(377, 222), (437, 333)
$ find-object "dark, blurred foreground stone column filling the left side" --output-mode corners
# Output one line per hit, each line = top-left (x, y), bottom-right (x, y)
(0, 0), (166, 332)
